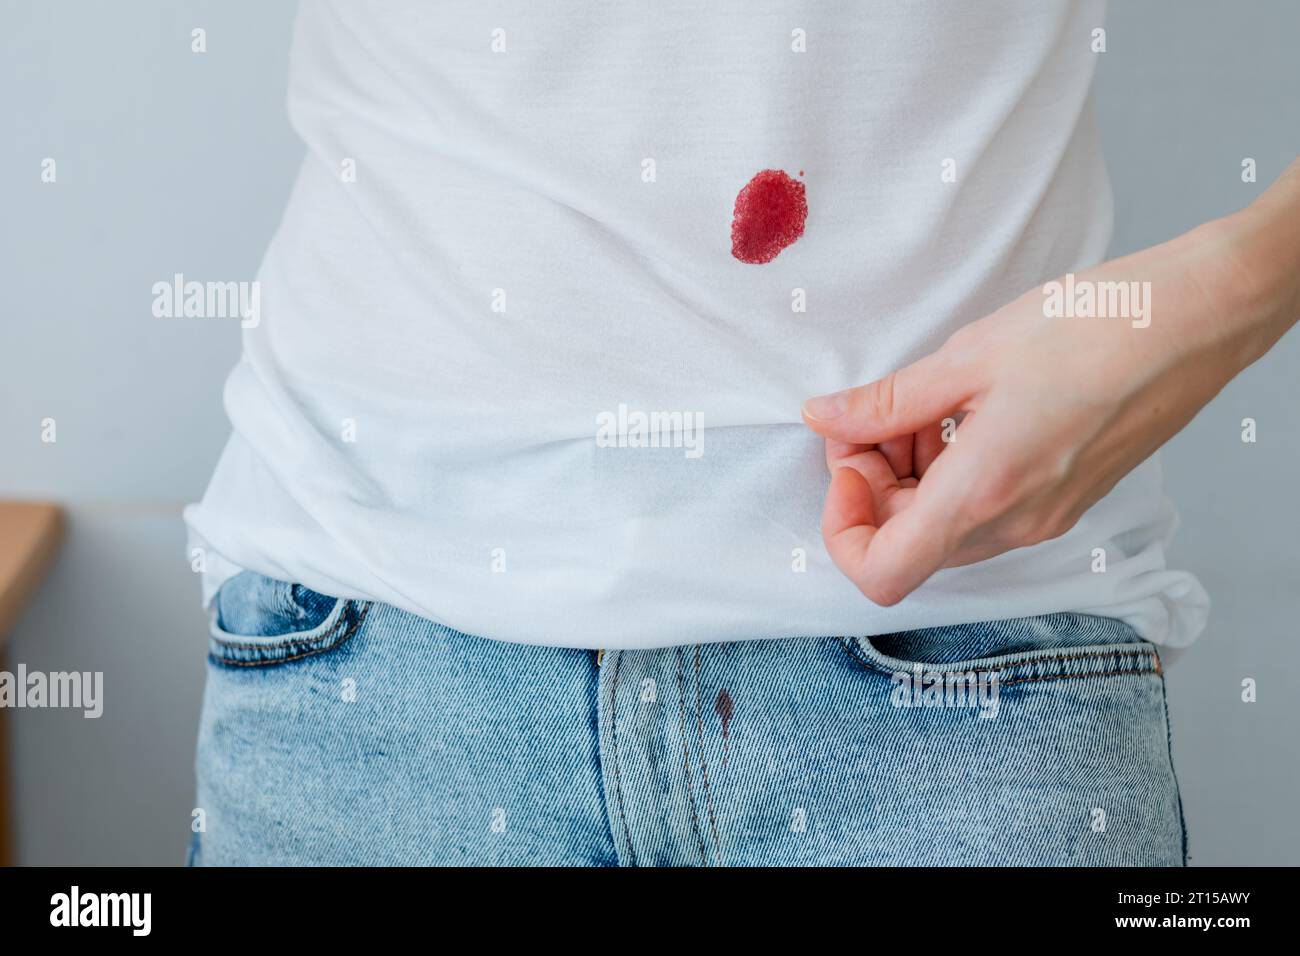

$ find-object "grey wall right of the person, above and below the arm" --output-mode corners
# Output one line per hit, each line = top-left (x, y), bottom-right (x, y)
(1097, 0), (1300, 865)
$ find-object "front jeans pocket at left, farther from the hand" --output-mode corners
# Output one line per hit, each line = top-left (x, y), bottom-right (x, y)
(208, 571), (371, 667)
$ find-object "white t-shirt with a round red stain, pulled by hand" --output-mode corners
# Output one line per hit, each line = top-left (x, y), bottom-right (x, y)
(180, 0), (1206, 648)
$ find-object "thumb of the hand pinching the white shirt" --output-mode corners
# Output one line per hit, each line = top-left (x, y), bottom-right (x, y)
(803, 350), (974, 444)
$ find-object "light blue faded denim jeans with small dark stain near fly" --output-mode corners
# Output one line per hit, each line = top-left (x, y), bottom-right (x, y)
(190, 572), (1186, 866)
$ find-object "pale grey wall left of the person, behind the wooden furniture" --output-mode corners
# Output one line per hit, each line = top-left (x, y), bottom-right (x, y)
(0, 0), (302, 864)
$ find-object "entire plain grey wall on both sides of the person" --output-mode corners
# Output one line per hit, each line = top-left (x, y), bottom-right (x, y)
(0, 0), (1300, 864)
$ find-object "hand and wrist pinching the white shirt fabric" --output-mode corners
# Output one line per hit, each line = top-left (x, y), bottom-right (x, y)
(803, 172), (1300, 605)
